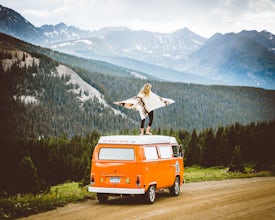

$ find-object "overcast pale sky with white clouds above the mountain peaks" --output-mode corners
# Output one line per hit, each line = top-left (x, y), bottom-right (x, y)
(0, 0), (275, 37)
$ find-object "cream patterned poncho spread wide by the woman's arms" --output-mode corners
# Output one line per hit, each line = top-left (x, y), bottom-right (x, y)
(114, 92), (175, 119)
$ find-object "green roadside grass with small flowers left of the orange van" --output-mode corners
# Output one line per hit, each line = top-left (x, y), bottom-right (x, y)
(0, 182), (95, 219)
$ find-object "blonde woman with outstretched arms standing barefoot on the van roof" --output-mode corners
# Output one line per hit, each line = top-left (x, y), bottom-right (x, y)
(114, 83), (175, 135)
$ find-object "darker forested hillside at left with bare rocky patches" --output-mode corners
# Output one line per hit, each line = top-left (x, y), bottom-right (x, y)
(0, 51), (135, 138)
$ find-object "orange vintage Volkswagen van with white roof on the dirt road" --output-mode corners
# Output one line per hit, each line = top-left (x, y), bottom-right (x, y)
(88, 135), (184, 203)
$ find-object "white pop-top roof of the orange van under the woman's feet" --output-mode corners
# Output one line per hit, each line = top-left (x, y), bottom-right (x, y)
(98, 135), (178, 145)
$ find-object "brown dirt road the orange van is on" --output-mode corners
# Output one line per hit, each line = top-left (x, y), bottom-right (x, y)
(19, 177), (275, 220)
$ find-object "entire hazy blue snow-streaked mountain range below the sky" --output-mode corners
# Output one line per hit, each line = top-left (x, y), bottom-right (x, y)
(0, 3), (275, 89)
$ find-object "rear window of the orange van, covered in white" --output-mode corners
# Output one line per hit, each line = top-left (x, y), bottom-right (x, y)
(98, 147), (135, 160)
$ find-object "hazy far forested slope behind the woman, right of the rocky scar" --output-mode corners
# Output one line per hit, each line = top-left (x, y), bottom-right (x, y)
(80, 70), (275, 130)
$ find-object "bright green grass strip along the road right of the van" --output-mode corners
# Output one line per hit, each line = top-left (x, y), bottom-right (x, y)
(184, 164), (272, 183)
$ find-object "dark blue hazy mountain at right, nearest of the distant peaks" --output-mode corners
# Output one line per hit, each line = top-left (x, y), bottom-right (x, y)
(182, 32), (275, 89)
